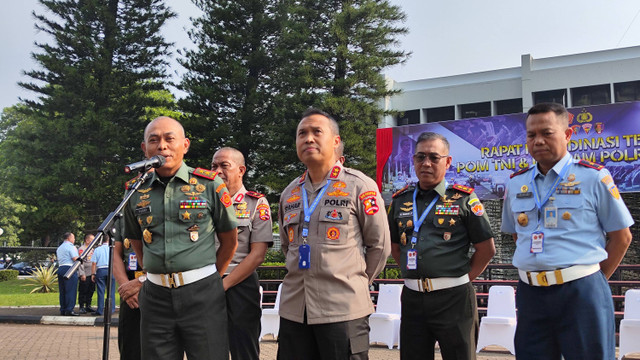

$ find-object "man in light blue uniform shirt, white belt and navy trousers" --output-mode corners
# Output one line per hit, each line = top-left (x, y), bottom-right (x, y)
(502, 103), (633, 360)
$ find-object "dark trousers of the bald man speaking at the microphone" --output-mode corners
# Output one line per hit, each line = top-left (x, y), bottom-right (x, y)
(139, 273), (229, 360)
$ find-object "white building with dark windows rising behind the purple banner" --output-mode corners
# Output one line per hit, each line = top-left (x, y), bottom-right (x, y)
(380, 46), (640, 127)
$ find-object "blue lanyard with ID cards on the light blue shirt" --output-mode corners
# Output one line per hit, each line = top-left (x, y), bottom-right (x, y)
(529, 158), (573, 254)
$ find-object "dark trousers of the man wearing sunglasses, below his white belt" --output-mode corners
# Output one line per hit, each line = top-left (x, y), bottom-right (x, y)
(400, 283), (478, 360)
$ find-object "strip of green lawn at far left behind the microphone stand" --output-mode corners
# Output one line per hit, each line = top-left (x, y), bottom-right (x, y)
(0, 279), (120, 307)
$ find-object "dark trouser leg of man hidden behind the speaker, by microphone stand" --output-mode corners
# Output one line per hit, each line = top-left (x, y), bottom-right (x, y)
(118, 271), (141, 360)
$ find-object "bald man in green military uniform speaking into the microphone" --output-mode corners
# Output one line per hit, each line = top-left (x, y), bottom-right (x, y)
(123, 117), (237, 360)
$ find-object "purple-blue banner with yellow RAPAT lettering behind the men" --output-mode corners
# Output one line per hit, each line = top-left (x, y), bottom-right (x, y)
(377, 101), (640, 204)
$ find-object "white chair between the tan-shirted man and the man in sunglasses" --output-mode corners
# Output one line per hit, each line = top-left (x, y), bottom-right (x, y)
(369, 284), (402, 349)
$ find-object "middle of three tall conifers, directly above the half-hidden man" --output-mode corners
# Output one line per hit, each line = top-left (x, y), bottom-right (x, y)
(180, 0), (281, 190)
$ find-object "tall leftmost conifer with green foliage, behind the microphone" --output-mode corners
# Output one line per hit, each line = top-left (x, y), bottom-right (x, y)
(0, 0), (174, 242)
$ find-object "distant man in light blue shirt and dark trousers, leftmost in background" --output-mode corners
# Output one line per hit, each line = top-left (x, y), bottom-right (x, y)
(56, 232), (80, 316)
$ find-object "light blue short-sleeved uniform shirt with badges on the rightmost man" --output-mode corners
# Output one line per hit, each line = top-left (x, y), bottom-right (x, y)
(501, 153), (633, 271)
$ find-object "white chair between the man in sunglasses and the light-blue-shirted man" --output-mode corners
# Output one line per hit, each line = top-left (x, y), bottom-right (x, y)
(476, 285), (516, 355)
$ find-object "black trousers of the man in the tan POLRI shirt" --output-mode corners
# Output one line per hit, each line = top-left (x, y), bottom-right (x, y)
(278, 311), (369, 360)
